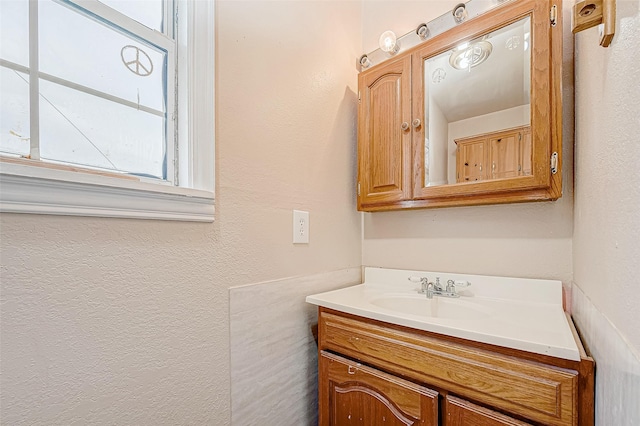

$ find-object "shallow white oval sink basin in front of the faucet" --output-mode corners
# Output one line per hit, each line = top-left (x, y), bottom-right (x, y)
(370, 294), (490, 320)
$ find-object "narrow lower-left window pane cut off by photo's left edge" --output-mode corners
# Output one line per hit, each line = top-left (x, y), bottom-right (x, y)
(0, 67), (30, 155)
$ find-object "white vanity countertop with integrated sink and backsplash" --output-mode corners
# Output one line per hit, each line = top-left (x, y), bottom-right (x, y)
(306, 267), (580, 361)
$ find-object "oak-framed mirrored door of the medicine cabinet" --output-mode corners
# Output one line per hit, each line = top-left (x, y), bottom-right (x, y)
(412, 1), (562, 203)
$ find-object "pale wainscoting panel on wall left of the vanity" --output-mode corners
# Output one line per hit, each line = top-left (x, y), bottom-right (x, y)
(229, 268), (361, 426)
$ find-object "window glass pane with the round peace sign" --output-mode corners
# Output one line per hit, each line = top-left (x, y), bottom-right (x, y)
(38, 0), (166, 112)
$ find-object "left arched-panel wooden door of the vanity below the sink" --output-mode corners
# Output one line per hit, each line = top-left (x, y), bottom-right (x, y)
(318, 351), (438, 426)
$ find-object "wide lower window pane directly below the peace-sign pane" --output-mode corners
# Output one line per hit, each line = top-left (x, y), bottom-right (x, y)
(40, 80), (164, 178)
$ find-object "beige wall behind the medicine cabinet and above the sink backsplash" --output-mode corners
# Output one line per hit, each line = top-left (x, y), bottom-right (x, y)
(362, 0), (573, 285)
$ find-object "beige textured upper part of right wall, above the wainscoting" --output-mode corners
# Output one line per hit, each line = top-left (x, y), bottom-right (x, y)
(574, 0), (640, 354)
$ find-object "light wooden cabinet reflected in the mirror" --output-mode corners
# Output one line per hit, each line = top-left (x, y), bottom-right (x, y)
(455, 126), (531, 182)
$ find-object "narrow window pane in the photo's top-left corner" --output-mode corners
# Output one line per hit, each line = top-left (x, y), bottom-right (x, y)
(0, 0), (29, 67)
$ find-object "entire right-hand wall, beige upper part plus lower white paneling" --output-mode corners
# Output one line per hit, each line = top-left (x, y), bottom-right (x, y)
(572, 0), (640, 425)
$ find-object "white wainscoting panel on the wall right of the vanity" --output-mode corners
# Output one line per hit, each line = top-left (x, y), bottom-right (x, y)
(571, 284), (640, 426)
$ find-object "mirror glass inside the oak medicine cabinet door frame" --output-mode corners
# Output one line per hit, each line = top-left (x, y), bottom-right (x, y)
(424, 17), (531, 186)
